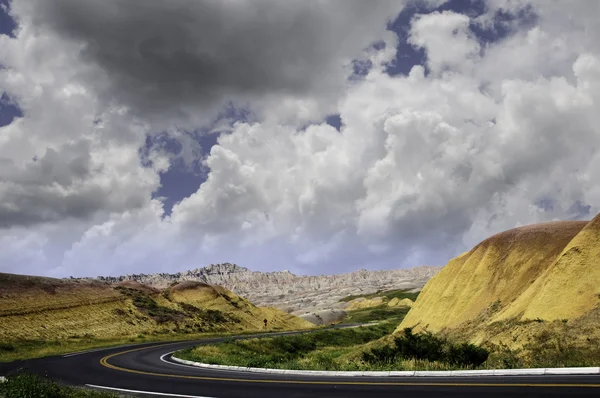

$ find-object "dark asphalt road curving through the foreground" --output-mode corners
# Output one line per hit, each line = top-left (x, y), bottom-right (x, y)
(0, 326), (600, 398)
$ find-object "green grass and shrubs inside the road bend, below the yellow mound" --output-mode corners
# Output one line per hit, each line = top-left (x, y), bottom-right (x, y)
(176, 306), (600, 371)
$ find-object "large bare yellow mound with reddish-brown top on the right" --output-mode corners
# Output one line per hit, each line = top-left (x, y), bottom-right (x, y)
(397, 215), (600, 346)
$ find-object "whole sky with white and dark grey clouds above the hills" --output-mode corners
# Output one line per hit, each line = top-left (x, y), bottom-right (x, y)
(0, 0), (600, 277)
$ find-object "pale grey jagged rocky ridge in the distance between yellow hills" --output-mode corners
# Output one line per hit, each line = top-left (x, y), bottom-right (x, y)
(92, 263), (441, 315)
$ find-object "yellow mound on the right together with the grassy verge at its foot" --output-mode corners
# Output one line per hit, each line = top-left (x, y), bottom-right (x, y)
(171, 216), (600, 370)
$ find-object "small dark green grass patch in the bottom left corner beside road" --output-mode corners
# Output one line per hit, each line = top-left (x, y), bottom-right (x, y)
(0, 372), (119, 398)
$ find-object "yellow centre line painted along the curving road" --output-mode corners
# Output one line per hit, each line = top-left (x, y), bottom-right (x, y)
(100, 342), (600, 388)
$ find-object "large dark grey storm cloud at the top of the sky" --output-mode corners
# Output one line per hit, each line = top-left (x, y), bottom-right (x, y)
(27, 0), (401, 123)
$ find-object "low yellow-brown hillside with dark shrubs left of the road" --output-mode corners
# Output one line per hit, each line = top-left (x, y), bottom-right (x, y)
(0, 274), (313, 361)
